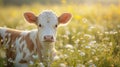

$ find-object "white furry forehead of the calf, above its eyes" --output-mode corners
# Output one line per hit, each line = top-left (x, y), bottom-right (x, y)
(38, 11), (58, 25)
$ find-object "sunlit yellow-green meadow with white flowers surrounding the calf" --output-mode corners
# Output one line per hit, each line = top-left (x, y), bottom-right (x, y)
(0, 4), (120, 67)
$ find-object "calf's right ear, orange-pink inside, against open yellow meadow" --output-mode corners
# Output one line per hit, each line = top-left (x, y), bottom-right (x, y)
(58, 13), (72, 24)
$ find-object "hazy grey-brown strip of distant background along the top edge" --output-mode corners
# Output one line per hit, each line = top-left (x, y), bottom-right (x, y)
(0, 0), (120, 6)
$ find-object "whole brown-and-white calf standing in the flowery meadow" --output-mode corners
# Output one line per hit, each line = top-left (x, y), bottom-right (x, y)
(0, 11), (71, 67)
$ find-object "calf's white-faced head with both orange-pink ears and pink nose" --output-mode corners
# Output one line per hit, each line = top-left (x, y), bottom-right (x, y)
(24, 11), (71, 42)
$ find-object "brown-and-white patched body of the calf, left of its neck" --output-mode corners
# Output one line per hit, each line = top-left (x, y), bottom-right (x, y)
(0, 28), (38, 66)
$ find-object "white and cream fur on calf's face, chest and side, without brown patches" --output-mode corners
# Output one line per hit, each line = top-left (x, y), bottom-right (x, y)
(0, 11), (71, 67)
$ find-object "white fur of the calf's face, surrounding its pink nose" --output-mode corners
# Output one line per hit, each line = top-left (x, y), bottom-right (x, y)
(38, 11), (58, 41)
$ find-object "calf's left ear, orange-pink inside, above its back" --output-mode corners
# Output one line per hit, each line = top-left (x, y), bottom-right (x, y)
(24, 12), (37, 24)
